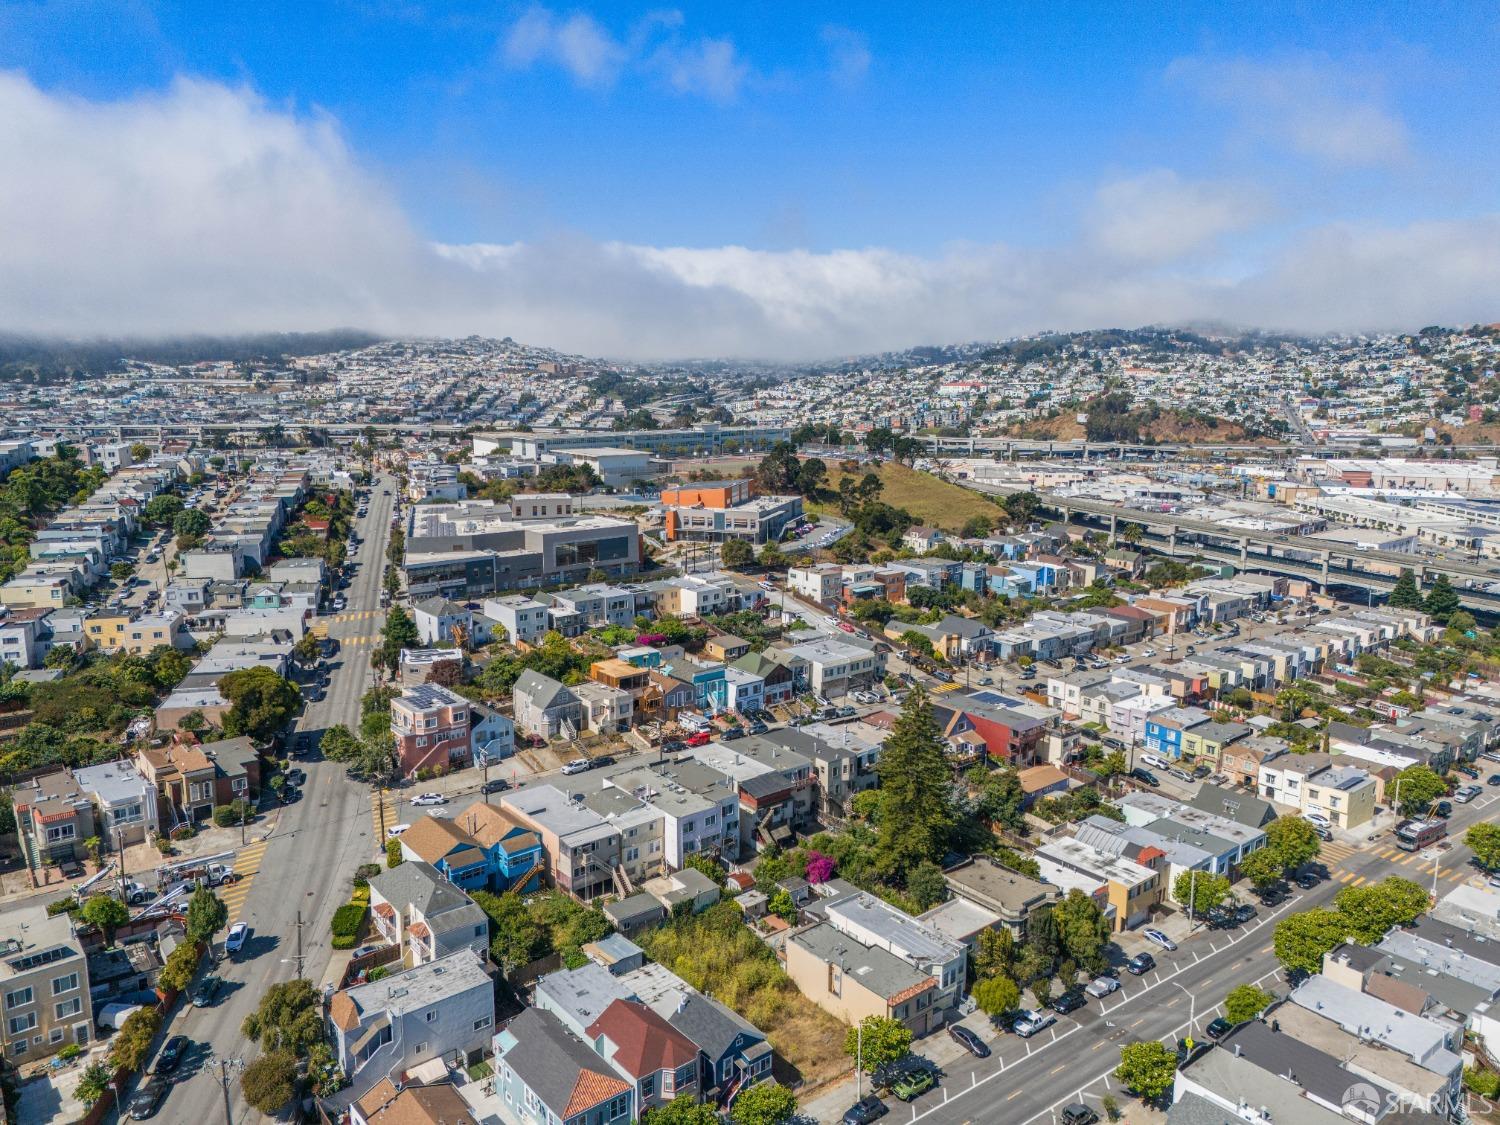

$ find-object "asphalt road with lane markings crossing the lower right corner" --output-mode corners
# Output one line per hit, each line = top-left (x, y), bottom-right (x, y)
(890, 789), (1500, 1125)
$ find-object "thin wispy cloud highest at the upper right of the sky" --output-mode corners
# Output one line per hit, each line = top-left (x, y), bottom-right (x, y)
(1167, 56), (1410, 167)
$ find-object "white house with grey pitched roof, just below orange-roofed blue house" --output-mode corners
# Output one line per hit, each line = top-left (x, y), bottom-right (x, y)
(369, 860), (489, 966)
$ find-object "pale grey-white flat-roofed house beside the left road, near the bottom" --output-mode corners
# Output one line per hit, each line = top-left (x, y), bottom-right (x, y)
(327, 950), (495, 1101)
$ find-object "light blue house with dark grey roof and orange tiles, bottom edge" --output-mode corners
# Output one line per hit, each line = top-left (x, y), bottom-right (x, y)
(492, 1008), (639, 1125)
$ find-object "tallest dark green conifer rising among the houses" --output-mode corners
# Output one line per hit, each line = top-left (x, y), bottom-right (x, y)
(876, 687), (956, 872)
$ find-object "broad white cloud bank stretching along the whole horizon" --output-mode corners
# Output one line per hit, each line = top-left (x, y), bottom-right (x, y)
(0, 74), (1500, 357)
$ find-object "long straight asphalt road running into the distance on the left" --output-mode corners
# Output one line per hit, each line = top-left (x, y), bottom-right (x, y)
(159, 477), (395, 1125)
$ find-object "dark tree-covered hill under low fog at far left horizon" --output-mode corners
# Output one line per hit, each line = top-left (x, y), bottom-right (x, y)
(0, 329), (383, 383)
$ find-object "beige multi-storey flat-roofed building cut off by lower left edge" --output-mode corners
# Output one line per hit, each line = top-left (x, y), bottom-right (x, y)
(0, 906), (93, 1067)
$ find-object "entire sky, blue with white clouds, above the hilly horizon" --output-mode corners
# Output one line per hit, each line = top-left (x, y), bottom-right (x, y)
(0, 0), (1500, 356)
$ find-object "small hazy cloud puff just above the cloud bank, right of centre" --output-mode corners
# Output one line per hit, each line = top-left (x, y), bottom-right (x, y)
(1088, 168), (1268, 263)
